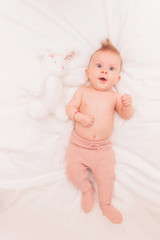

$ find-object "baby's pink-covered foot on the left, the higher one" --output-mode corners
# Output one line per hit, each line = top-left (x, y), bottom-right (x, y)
(81, 188), (94, 213)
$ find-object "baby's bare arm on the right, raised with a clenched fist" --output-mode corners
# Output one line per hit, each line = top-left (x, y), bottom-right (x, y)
(116, 93), (134, 119)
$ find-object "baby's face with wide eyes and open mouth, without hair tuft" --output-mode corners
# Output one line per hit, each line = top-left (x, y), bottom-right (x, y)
(86, 50), (121, 91)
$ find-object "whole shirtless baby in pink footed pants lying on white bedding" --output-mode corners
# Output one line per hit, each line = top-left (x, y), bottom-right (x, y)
(66, 39), (134, 224)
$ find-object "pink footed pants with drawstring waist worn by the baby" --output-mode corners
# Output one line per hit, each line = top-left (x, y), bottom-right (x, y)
(66, 131), (122, 223)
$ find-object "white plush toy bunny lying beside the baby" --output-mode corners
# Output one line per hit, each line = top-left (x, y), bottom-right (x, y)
(29, 51), (75, 121)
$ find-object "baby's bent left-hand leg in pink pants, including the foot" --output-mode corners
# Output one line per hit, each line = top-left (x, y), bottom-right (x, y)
(66, 144), (94, 213)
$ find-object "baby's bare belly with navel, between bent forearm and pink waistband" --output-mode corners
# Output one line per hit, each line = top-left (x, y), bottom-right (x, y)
(75, 120), (113, 141)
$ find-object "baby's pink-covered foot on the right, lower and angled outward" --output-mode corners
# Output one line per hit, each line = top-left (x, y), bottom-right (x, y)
(101, 205), (122, 224)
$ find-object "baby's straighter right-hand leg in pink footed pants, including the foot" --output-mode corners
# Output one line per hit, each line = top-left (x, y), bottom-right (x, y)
(93, 148), (122, 223)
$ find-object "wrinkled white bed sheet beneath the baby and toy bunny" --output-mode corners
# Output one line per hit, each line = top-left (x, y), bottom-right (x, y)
(0, 0), (160, 240)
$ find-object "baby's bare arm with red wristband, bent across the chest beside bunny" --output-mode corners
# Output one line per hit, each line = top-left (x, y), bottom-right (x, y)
(66, 87), (94, 127)
